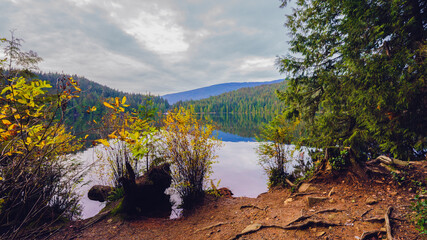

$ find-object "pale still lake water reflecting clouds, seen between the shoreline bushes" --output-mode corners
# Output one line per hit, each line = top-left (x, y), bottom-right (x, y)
(78, 131), (307, 219)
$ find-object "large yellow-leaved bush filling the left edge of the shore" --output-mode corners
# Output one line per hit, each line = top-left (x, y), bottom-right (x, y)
(0, 77), (82, 238)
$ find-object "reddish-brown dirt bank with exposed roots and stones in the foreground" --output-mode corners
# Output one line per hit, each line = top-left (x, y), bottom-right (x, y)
(50, 172), (427, 240)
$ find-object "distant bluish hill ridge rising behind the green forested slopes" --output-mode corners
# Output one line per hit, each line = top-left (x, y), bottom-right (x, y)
(162, 79), (283, 104)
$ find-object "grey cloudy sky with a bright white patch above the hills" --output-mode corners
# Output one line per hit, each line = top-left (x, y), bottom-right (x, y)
(0, 0), (289, 95)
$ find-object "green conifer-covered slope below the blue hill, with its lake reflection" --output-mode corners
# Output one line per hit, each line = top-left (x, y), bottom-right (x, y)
(172, 81), (287, 138)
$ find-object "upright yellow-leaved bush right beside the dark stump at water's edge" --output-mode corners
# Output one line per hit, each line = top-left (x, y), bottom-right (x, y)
(163, 108), (220, 209)
